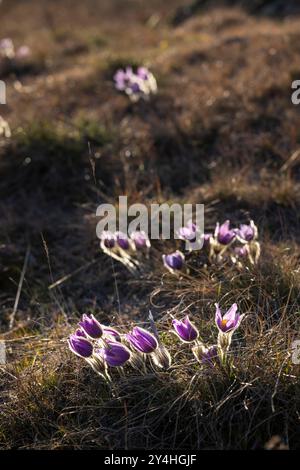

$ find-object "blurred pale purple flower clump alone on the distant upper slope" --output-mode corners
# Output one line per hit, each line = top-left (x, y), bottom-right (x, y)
(114, 67), (157, 102)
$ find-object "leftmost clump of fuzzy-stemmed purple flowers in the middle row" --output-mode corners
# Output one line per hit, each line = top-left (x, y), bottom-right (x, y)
(100, 231), (151, 272)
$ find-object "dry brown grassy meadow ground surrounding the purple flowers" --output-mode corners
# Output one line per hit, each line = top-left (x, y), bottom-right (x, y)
(0, 0), (300, 449)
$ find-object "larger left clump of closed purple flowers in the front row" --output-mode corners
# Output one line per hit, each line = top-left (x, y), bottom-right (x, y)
(68, 314), (171, 380)
